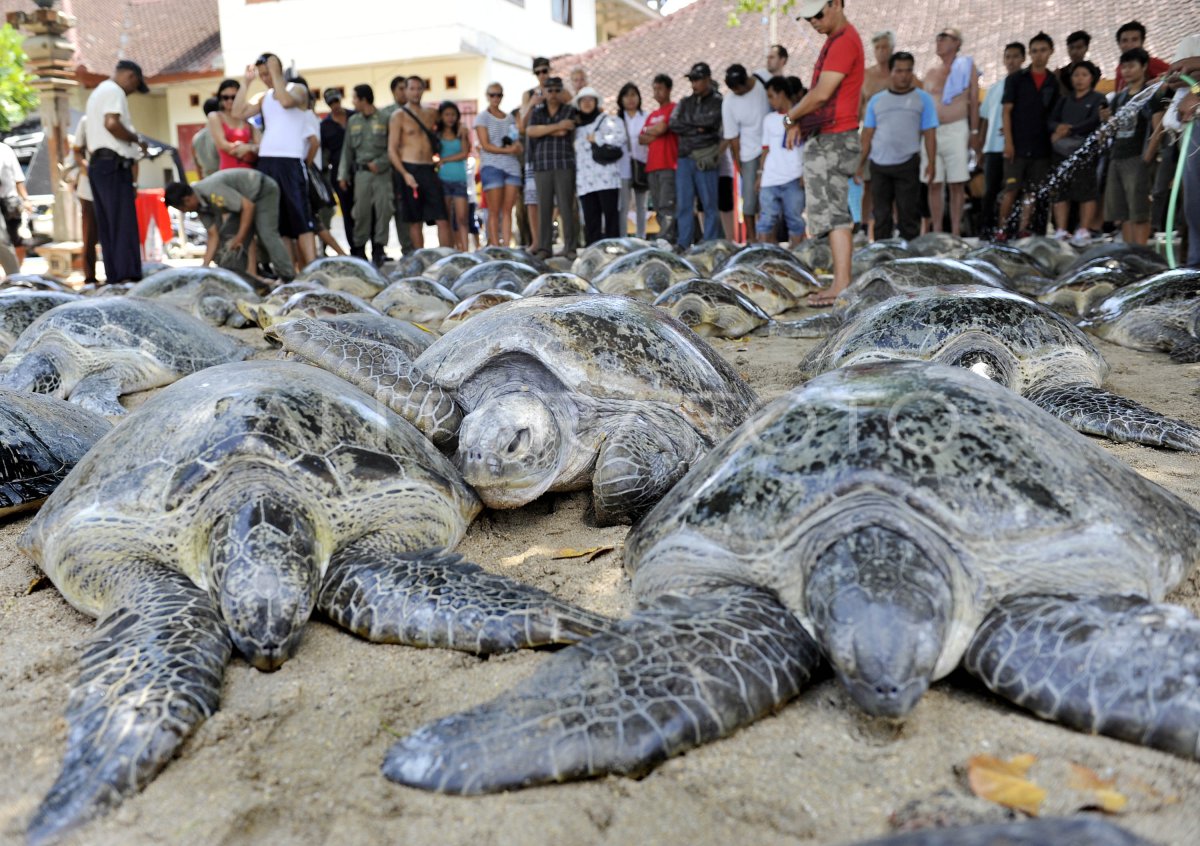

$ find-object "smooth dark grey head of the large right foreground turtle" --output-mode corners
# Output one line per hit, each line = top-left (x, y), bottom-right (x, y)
(805, 526), (953, 716)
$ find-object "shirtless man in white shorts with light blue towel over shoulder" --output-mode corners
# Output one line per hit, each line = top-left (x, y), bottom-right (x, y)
(920, 26), (983, 236)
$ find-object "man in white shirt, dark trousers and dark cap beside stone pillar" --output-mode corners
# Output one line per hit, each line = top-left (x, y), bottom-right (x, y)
(88, 59), (150, 282)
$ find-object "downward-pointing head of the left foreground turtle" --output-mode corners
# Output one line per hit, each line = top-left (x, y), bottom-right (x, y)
(209, 493), (320, 671)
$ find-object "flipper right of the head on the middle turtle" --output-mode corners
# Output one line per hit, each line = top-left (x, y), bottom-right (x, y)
(592, 419), (702, 526)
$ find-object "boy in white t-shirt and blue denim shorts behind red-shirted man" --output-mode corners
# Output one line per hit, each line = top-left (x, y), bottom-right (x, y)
(755, 77), (804, 246)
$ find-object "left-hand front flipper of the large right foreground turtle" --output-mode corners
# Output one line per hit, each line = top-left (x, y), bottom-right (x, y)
(383, 588), (821, 794)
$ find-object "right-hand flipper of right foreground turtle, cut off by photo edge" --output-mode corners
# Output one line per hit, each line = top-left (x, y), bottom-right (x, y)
(964, 596), (1200, 758)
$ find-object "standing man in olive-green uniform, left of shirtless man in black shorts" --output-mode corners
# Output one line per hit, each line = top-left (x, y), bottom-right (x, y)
(337, 85), (395, 268)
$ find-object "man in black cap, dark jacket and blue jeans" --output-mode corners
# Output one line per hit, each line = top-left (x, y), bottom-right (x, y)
(667, 61), (721, 250)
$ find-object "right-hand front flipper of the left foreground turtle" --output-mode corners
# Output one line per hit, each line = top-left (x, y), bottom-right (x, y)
(318, 544), (612, 655)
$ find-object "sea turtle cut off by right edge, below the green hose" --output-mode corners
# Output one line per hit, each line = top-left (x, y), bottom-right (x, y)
(1080, 268), (1200, 361)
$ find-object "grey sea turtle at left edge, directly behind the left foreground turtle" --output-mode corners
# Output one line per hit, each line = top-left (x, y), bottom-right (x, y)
(0, 296), (250, 415)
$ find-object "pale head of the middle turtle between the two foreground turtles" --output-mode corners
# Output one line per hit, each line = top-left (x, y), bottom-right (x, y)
(457, 391), (563, 508)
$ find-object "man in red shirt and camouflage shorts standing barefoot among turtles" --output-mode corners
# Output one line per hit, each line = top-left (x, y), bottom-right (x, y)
(784, 0), (865, 307)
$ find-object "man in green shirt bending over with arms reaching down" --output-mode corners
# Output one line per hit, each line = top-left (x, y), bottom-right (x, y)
(164, 168), (296, 282)
